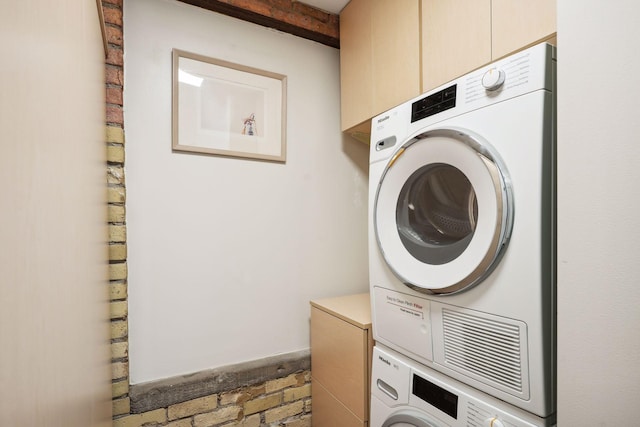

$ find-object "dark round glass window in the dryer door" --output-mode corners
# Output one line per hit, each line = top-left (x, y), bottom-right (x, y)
(396, 163), (478, 265)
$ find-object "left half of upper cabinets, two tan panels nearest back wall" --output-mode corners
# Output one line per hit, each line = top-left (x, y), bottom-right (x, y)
(340, 0), (420, 135)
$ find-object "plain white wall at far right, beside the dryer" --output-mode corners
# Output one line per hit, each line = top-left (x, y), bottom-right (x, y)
(558, 0), (640, 427)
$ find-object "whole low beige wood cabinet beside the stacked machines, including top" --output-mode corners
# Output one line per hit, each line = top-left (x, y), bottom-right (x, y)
(311, 293), (373, 427)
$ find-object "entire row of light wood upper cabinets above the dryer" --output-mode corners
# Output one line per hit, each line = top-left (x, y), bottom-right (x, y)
(340, 0), (556, 142)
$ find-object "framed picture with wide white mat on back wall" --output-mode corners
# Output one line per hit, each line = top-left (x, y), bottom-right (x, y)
(172, 49), (287, 162)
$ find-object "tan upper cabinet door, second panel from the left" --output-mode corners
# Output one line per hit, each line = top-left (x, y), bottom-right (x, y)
(371, 0), (420, 116)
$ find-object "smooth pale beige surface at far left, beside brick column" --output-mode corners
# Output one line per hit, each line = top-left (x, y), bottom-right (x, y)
(0, 0), (111, 427)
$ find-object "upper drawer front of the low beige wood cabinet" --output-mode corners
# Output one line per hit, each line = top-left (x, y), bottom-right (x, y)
(311, 307), (369, 420)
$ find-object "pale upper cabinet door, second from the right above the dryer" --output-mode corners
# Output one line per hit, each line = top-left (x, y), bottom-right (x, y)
(422, 0), (490, 92)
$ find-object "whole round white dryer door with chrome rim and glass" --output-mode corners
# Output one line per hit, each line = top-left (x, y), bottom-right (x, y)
(373, 129), (513, 294)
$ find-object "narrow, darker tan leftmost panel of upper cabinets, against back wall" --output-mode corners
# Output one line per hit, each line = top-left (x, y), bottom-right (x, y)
(340, 0), (373, 130)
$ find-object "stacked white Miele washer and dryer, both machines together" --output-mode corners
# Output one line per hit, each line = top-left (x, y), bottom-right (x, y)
(369, 44), (556, 427)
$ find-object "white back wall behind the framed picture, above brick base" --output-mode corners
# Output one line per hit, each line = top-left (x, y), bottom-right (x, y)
(124, 0), (368, 383)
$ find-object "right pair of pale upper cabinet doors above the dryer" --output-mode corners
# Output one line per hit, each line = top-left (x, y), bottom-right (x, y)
(421, 0), (556, 91)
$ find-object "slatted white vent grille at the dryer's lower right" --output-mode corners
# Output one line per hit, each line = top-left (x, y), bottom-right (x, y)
(442, 309), (523, 394)
